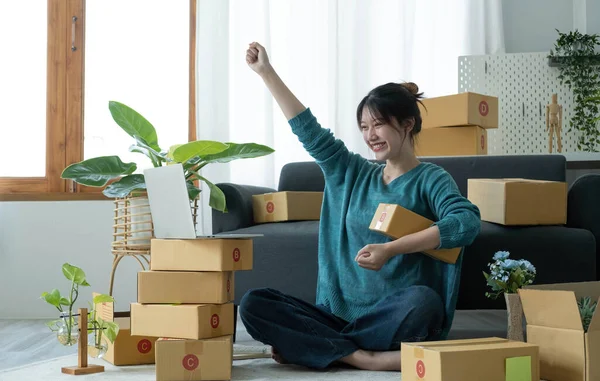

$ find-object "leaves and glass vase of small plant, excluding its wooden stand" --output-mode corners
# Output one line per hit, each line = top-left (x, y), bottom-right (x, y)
(41, 263), (119, 357)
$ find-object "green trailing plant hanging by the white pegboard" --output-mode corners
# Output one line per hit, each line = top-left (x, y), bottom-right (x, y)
(548, 29), (600, 152)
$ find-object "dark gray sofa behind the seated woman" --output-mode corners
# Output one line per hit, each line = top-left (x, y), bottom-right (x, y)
(212, 155), (600, 338)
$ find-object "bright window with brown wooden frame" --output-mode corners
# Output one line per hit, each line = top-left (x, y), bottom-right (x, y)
(0, 0), (196, 200)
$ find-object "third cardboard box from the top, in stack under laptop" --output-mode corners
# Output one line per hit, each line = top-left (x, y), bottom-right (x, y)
(131, 303), (234, 340)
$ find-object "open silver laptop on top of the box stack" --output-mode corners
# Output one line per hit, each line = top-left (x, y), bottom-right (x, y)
(144, 163), (263, 239)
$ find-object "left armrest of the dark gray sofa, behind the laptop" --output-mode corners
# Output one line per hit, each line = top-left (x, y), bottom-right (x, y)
(211, 183), (276, 234)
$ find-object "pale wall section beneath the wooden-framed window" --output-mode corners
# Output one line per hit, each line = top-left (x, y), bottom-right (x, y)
(0, 201), (140, 318)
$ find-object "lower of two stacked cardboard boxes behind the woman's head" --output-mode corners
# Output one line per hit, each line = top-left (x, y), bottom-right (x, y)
(415, 126), (487, 156)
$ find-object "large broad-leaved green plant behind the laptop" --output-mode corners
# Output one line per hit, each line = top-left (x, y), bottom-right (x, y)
(61, 101), (274, 212)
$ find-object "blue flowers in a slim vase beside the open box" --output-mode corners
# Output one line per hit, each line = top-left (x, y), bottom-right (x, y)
(483, 251), (536, 341)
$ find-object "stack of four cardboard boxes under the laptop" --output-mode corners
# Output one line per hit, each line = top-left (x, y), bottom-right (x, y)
(131, 237), (253, 381)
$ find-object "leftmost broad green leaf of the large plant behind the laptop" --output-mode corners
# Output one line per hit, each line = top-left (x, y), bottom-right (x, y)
(61, 156), (137, 187)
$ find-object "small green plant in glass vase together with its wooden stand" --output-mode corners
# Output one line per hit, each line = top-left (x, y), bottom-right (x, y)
(41, 263), (119, 374)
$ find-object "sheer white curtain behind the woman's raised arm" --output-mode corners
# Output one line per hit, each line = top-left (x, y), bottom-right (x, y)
(196, 0), (504, 234)
